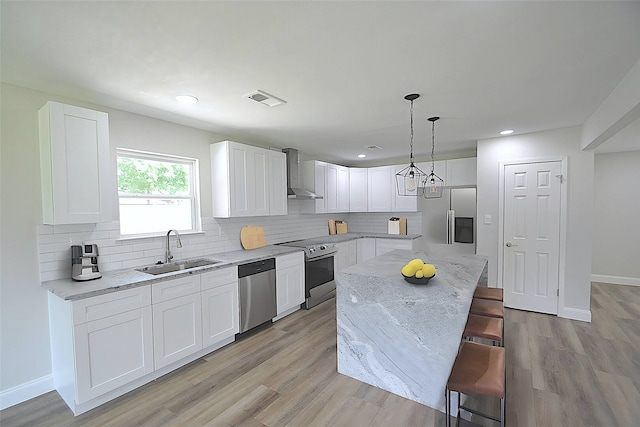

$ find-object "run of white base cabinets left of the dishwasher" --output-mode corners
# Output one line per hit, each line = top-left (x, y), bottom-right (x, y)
(48, 261), (238, 415)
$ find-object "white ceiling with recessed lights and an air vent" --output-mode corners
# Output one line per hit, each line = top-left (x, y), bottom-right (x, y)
(0, 0), (640, 165)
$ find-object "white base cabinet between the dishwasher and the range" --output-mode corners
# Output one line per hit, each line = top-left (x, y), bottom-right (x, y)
(276, 252), (305, 319)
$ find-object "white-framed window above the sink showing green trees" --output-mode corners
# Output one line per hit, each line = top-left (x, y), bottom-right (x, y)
(117, 148), (201, 236)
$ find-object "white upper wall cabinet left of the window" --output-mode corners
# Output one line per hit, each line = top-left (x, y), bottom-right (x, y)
(39, 102), (115, 224)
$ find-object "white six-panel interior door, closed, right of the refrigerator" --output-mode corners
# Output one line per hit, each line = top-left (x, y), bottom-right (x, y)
(502, 162), (562, 314)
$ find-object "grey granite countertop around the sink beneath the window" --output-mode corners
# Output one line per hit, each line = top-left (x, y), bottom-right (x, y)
(42, 245), (302, 300)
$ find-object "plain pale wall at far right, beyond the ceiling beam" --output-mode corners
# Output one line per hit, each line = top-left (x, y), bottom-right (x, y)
(591, 150), (640, 285)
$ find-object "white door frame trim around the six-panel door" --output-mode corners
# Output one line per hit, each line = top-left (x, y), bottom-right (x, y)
(497, 156), (569, 315)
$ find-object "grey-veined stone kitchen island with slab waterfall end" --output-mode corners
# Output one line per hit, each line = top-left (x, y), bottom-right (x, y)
(335, 250), (487, 411)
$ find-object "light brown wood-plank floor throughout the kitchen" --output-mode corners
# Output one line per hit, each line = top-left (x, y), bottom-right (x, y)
(0, 283), (640, 427)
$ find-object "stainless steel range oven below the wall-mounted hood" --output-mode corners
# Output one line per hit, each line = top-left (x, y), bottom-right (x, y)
(282, 240), (338, 309)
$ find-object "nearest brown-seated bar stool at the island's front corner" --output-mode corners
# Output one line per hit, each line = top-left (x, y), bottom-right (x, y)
(445, 341), (507, 427)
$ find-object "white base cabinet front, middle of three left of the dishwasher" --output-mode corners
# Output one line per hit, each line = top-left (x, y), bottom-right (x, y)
(152, 274), (202, 369)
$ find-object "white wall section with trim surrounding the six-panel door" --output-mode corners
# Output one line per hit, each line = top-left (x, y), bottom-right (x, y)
(477, 128), (594, 320)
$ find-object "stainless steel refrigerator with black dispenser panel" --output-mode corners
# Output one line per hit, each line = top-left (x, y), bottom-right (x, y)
(420, 188), (477, 254)
